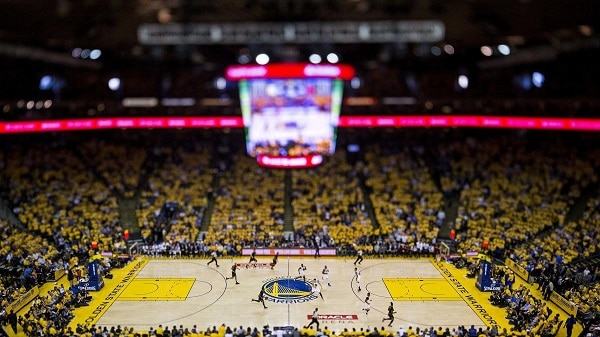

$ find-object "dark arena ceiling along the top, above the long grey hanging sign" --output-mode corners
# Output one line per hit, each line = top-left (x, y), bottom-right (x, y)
(0, 0), (600, 54)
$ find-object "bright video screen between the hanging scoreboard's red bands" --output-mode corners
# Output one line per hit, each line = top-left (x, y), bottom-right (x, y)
(240, 78), (342, 156)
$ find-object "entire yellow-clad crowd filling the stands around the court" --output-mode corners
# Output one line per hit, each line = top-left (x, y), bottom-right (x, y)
(0, 132), (600, 337)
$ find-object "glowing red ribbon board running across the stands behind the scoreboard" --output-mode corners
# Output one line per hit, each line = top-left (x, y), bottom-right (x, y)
(0, 116), (600, 134)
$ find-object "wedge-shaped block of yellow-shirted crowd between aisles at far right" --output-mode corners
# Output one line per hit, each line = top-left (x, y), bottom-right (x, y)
(442, 138), (594, 255)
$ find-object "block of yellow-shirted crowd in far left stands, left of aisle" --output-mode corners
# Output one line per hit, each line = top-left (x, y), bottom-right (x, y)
(6, 146), (122, 250)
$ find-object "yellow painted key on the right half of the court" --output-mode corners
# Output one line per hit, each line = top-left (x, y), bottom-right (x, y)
(383, 278), (461, 301)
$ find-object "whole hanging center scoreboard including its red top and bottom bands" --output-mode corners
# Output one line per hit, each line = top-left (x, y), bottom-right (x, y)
(226, 63), (354, 168)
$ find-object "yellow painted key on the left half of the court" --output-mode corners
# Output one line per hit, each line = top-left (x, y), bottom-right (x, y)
(118, 278), (196, 301)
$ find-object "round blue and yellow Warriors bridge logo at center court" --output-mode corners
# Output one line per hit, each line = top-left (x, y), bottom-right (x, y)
(263, 277), (318, 304)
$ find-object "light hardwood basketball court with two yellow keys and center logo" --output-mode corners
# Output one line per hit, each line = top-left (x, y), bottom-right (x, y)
(73, 257), (500, 329)
